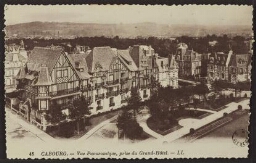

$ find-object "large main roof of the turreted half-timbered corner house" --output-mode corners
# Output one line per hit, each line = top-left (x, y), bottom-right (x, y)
(28, 47), (64, 72)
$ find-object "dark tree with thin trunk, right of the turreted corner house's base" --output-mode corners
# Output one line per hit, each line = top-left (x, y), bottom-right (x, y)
(69, 96), (91, 133)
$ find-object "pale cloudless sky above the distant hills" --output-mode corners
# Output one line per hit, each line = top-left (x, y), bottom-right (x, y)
(5, 5), (253, 25)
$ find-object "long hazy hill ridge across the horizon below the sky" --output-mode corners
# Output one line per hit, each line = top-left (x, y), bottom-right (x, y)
(6, 22), (252, 38)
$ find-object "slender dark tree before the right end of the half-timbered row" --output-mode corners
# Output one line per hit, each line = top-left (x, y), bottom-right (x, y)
(128, 88), (142, 118)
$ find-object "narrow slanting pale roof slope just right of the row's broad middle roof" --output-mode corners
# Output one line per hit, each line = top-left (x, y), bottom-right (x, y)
(117, 49), (138, 71)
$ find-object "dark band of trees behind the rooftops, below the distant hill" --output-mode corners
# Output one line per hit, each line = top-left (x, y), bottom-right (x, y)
(6, 35), (250, 57)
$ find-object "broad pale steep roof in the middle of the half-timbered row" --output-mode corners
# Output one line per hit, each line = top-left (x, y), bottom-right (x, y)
(86, 46), (116, 72)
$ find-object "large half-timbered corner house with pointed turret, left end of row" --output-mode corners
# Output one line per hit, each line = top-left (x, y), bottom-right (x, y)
(17, 47), (81, 130)
